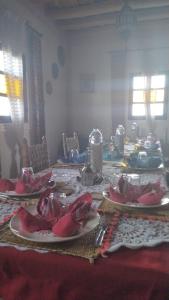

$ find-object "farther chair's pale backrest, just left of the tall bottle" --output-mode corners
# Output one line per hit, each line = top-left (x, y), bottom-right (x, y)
(62, 132), (80, 158)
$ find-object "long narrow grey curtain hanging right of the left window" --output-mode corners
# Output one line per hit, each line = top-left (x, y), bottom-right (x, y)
(26, 24), (45, 145)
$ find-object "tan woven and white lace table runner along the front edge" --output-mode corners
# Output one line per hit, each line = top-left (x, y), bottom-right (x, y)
(0, 200), (169, 263)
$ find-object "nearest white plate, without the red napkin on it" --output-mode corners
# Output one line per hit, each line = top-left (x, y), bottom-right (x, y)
(10, 207), (100, 243)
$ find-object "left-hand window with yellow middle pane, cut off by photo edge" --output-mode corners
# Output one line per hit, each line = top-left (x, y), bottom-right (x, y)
(0, 48), (23, 123)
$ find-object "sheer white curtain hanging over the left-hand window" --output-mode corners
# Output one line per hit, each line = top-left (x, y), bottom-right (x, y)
(0, 9), (24, 178)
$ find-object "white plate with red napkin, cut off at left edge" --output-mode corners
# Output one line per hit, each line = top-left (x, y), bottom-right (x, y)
(0, 172), (52, 197)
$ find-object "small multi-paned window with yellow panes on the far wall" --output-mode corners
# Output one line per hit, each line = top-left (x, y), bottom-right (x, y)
(129, 74), (167, 119)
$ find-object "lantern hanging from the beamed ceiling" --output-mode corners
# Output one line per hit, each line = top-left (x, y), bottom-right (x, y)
(115, 0), (137, 40)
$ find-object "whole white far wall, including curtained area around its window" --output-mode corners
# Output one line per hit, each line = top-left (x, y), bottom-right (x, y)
(68, 20), (169, 144)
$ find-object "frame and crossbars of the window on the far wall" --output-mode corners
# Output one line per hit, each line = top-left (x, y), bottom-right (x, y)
(128, 71), (169, 121)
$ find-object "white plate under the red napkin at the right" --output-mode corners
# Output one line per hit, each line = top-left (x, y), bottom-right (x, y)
(103, 191), (169, 208)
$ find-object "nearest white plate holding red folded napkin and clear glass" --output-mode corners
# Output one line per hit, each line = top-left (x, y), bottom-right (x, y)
(10, 190), (100, 243)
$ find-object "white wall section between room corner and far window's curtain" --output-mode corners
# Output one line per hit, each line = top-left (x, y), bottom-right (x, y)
(68, 29), (117, 142)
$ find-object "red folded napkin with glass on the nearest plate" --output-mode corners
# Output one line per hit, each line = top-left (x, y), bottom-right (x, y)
(17, 190), (92, 237)
